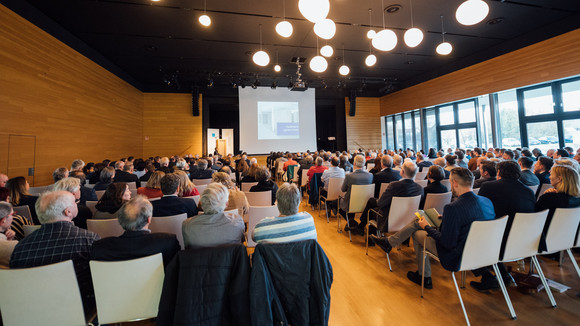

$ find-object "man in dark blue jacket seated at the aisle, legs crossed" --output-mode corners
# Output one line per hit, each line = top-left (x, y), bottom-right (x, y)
(371, 168), (495, 289)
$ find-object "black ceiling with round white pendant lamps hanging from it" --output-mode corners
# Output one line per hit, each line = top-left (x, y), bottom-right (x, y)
(1, 0), (580, 95)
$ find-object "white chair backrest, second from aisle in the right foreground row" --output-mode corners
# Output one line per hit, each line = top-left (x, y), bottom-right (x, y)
(502, 209), (548, 261)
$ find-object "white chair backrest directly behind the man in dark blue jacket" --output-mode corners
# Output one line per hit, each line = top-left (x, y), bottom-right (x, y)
(459, 216), (508, 271)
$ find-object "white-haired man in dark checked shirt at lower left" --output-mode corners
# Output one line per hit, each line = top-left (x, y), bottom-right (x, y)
(10, 190), (100, 313)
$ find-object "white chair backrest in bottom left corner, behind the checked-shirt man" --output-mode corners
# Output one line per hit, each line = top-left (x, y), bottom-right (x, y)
(0, 260), (86, 326)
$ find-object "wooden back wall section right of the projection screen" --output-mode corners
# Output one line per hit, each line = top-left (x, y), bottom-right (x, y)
(345, 97), (382, 150)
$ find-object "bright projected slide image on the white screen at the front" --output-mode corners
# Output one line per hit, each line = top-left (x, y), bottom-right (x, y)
(258, 102), (300, 139)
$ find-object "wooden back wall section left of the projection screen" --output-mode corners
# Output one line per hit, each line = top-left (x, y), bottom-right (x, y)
(143, 93), (202, 157)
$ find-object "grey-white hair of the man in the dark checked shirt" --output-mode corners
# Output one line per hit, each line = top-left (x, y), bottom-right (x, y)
(34, 190), (76, 224)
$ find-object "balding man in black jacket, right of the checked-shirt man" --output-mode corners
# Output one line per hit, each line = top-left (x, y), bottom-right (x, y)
(91, 196), (181, 266)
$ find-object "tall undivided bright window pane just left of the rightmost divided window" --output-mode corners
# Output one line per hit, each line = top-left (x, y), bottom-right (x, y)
(497, 90), (529, 147)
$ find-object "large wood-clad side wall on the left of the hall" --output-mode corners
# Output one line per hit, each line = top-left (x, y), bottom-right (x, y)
(0, 5), (143, 186)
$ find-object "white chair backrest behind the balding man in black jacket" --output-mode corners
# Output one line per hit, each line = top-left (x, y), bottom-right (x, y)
(89, 253), (165, 324)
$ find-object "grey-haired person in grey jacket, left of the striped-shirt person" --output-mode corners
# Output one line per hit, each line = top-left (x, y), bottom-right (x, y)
(182, 182), (245, 249)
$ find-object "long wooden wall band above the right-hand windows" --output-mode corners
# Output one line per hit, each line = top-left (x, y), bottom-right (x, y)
(381, 29), (580, 116)
